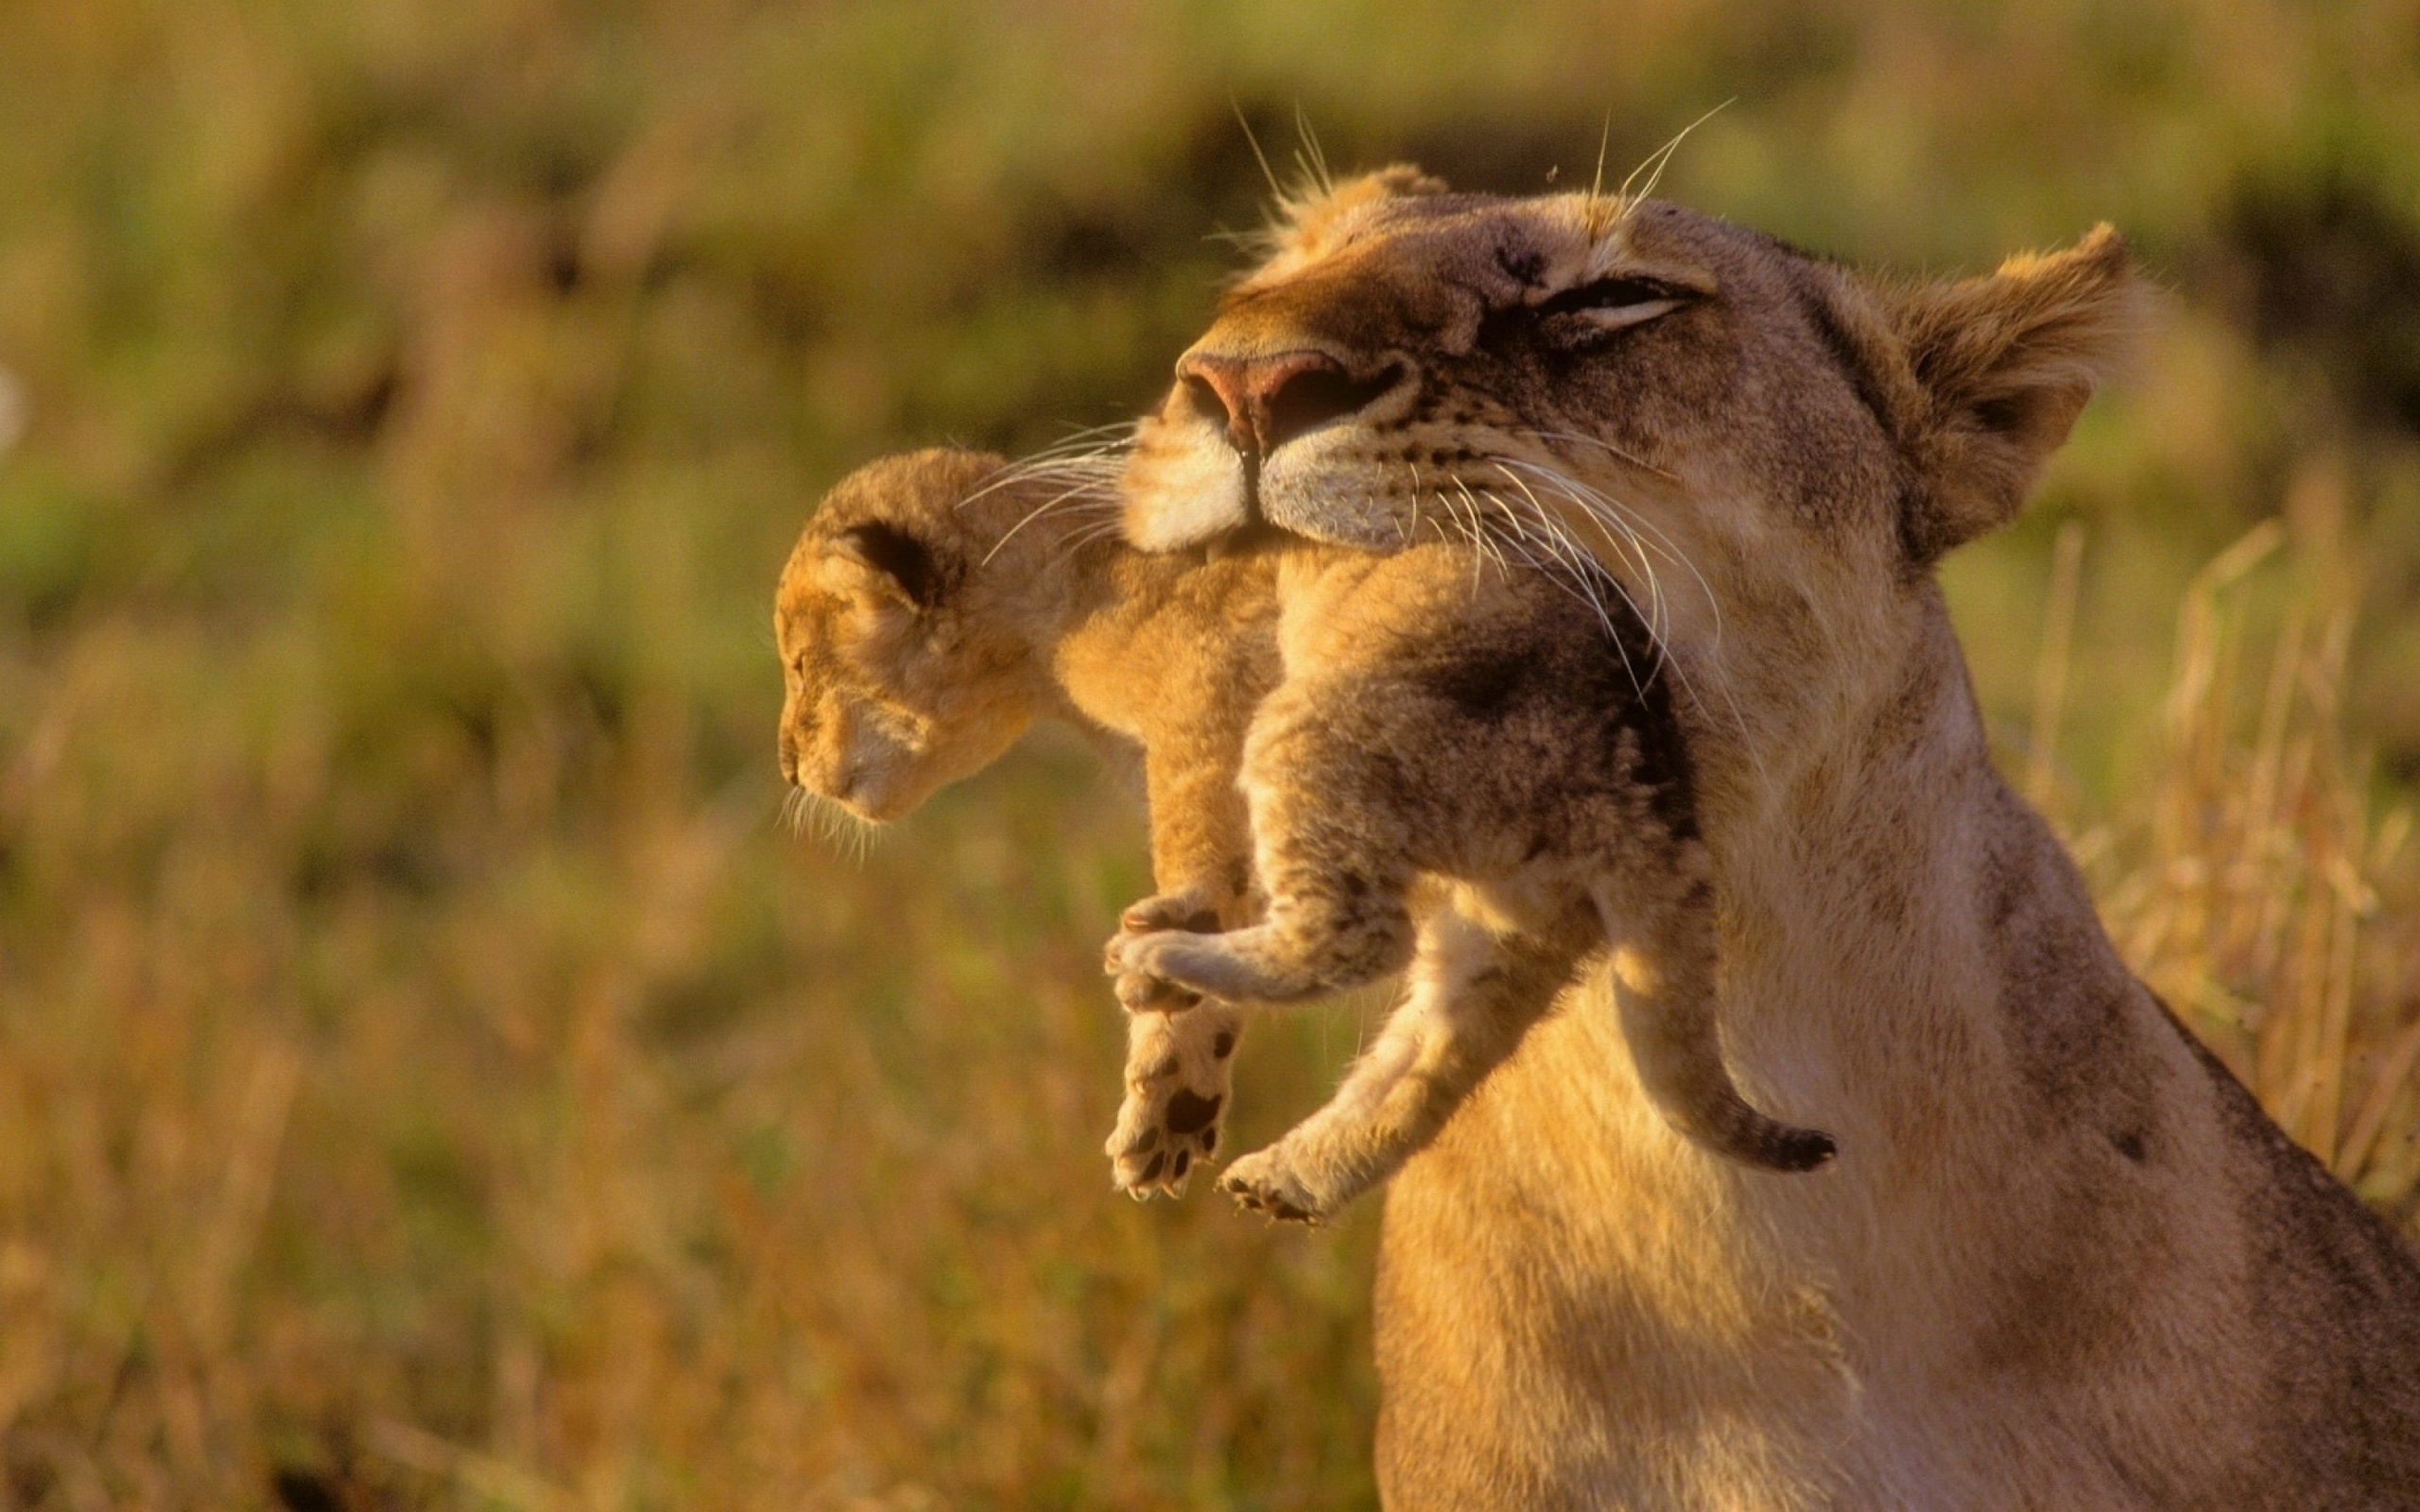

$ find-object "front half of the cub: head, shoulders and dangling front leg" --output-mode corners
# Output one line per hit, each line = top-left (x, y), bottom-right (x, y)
(774, 450), (1278, 1197)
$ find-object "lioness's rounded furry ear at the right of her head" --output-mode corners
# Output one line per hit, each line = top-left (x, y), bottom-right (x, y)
(1888, 225), (2144, 563)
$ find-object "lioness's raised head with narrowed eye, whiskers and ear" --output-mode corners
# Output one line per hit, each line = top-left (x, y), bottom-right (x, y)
(1125, 169), (2136, 720)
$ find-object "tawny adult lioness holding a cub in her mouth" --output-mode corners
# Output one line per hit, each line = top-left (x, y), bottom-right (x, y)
(1128, 169), (2420, 1512)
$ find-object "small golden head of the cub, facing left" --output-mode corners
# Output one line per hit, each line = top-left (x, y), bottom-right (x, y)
(772, 450), (1069, 822)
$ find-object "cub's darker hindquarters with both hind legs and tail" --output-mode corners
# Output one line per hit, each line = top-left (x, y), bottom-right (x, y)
(1108, 529), (1834, 1219)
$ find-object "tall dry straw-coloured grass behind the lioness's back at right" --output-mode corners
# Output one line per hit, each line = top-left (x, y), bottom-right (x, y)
(2062, 495), (2420, 1224)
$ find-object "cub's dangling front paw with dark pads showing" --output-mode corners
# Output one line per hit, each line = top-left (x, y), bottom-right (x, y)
(1108, 1002), (1244, 1200)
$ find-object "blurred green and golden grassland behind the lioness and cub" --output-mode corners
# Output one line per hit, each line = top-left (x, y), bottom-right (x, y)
(0, 0), (2420, 1512)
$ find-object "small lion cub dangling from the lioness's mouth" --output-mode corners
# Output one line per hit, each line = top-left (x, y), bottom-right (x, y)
(774, 450), (1832, 1219)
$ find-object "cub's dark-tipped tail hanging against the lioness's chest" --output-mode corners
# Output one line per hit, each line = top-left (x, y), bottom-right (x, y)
(1590, 839), (1834, 1171)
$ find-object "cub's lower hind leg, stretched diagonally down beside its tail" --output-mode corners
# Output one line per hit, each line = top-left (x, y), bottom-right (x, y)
(1219, 907), (1595, 1222)
